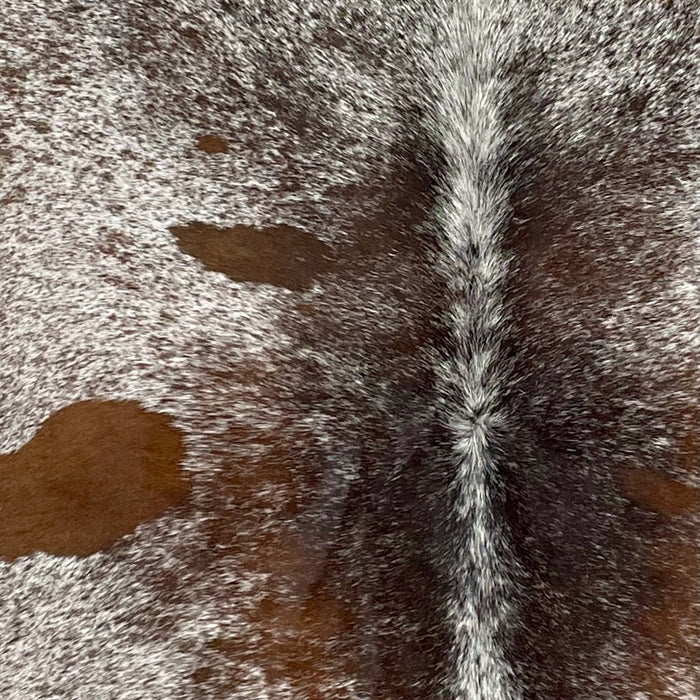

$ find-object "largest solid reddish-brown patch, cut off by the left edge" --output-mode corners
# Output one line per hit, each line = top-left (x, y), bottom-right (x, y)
(0, 401), (190, 561)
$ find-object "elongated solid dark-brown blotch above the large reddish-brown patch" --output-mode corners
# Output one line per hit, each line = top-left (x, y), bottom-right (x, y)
(169, 221), (333, 291)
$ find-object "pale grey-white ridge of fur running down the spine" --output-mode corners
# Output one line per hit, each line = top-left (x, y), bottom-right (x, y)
(430, 0), (521, 700)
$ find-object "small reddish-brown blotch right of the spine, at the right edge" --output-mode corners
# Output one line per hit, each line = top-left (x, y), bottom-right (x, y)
(622, 469), (700, 516)
